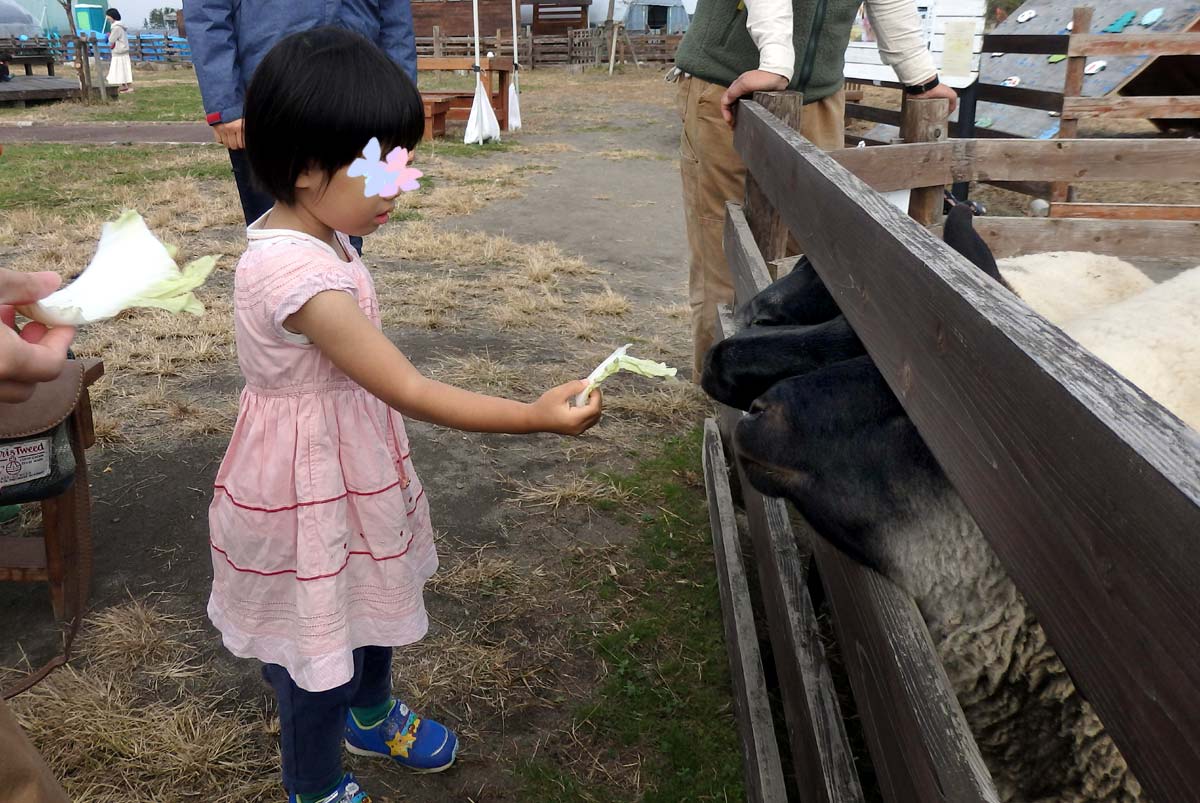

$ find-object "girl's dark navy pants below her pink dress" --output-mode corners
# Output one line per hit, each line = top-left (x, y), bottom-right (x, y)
(263, 647), (391, 795)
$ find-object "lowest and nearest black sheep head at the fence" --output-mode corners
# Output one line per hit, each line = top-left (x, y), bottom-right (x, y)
(734, 356), (947, 568)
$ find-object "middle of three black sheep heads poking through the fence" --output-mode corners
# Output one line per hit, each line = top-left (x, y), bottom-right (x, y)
(701, 316), (866, 409)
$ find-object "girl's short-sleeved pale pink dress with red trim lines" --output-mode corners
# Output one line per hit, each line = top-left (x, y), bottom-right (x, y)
(209, 220), (438, 691)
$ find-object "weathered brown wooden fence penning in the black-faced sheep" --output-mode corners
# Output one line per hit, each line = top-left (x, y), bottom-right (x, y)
(704, 94), (1200, 803)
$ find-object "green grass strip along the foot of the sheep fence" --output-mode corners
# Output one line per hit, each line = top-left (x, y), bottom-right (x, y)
(521, 427), (744, 803)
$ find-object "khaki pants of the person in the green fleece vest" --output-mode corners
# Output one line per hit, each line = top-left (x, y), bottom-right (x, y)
(677, 77), (846, 383)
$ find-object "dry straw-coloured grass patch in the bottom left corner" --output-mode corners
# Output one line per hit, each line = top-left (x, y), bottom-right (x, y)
(11, 600), (278, 803)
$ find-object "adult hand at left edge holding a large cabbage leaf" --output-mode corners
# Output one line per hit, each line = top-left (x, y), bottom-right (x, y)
(0, 270), (74, 403)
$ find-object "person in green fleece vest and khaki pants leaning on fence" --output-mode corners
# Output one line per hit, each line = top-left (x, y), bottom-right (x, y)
(676, 0), (955, 372)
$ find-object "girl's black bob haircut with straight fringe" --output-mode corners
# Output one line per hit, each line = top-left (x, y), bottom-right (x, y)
(244, 28), (425, 204)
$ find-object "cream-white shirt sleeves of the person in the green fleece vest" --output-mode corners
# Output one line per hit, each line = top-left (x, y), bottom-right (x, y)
(744, 0), (937, 86)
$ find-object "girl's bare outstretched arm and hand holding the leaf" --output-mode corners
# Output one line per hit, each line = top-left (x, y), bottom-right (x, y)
(283, 290), (600, 435)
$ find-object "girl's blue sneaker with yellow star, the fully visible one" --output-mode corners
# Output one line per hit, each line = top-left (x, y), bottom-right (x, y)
(346, 700), (458, 773)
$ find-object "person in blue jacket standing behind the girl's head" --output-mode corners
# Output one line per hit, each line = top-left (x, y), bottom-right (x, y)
(184, 0), (416, 244)
